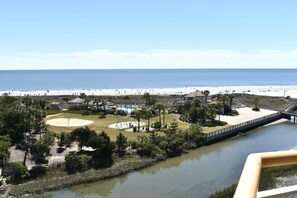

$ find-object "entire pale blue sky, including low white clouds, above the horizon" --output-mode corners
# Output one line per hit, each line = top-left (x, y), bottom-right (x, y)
(0, 0), (297, 69)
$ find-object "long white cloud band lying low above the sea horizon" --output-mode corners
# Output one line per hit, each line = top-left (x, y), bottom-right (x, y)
(0, 49), (297, 70)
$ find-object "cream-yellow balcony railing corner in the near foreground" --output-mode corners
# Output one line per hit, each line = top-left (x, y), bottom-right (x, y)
(234, 150), (297, 198)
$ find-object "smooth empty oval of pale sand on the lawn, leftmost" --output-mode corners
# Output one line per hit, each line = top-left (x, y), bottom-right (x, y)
(46, 118), (94, 127)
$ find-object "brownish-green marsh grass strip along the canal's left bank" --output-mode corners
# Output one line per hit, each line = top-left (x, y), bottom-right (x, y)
(8, 158), (157, 197)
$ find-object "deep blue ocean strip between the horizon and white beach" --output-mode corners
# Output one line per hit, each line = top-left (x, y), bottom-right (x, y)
(0, 69), (297, 91)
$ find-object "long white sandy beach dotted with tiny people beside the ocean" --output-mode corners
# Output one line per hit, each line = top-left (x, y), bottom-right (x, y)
(0, 85), (297, 98)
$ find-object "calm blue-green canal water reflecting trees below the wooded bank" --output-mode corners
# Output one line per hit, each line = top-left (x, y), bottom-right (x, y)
(49, 122), (297, 198)
